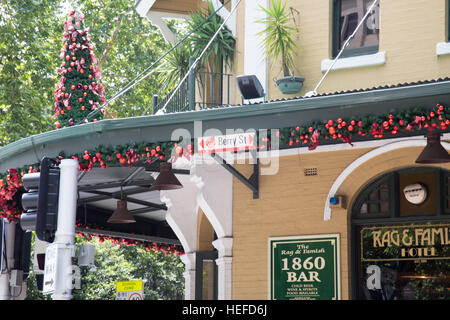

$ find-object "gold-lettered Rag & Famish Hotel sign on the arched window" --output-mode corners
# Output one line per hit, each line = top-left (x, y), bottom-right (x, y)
(360, 224), (450, 261)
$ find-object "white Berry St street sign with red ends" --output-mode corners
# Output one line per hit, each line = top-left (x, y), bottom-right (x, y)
(198, 132), (256, 153)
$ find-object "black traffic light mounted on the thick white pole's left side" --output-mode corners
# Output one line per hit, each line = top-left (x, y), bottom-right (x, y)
(20, 157), (59, 242)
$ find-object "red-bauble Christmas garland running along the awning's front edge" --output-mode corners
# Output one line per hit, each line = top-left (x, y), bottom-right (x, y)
(0, 104), (450, 221)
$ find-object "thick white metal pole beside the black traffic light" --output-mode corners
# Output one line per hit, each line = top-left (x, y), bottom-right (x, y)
(52, 159), (78, 300)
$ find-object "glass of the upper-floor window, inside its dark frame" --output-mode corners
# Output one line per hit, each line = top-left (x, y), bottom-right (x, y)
(339, 0), (380, 48)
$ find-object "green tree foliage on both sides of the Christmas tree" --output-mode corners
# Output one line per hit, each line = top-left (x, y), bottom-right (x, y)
(0, 0), (168, 146)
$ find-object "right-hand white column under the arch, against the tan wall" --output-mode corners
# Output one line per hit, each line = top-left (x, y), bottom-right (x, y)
(213, 237), (233, 300)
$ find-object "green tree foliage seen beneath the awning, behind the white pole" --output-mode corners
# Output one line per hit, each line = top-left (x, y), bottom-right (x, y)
(27, 236), (184, 300)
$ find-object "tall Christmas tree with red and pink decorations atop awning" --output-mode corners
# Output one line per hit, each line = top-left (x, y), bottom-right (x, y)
(53, 11), (106, 128)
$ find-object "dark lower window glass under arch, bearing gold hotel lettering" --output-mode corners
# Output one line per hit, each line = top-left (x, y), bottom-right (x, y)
(358, 224), (450, 300)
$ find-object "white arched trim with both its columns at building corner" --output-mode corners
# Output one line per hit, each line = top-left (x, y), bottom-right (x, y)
(160, 155), (233, 300)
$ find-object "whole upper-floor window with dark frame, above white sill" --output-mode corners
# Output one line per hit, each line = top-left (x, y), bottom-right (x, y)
(333, 0), (380, 57)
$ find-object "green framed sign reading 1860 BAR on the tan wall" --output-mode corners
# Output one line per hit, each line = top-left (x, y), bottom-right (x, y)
(269, 234), (341, 300)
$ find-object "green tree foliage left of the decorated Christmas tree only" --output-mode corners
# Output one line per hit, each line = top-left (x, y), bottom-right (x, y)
(0, 0), (62, 145)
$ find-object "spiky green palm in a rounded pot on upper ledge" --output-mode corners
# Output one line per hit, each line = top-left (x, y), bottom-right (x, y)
(257, 0), (305, 94)
